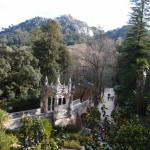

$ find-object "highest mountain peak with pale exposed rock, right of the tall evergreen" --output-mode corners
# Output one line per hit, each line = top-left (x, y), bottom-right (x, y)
(56, 15), (92, 45)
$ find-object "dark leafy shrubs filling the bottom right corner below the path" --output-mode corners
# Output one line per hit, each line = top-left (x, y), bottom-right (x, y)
(83, 107), (150, 150)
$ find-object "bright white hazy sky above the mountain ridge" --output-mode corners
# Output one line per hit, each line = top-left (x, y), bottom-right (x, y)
(0, 0), (130, 31)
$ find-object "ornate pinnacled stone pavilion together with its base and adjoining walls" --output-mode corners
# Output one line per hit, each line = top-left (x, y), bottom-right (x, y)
(7, 72), (93, 129)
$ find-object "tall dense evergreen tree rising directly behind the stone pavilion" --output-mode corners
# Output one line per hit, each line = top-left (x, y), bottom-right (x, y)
(33, 20), (69, 81)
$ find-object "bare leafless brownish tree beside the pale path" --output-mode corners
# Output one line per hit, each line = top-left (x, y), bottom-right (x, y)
(72, 38), (117, 104)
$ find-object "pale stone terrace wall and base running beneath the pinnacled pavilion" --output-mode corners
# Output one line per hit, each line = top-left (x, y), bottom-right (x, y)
(6, 99), (93, 129)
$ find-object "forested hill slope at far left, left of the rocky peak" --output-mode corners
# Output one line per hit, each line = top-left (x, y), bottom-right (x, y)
(0, 17), (47, 50)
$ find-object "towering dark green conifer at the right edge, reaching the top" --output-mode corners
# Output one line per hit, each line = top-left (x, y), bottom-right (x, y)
(118, 0), (150, 113)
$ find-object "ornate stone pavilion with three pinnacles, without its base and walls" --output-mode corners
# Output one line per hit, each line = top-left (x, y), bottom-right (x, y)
(41, 72), (72, 113)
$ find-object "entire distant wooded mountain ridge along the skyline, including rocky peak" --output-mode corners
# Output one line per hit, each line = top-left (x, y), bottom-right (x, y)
(0, 15), (129, 49)
